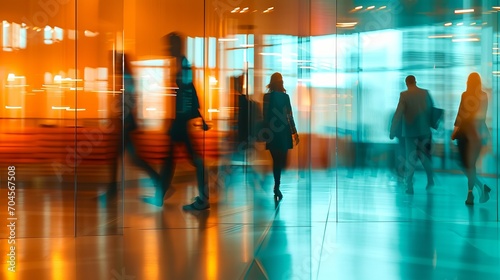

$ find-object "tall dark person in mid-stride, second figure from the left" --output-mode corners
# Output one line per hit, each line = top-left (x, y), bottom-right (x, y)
(143, 32), (210, 210)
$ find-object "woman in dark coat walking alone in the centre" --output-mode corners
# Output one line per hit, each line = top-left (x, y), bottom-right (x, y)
(263, 72), (299, 200)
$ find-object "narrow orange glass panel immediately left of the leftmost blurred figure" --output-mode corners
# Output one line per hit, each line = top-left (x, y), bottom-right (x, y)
(70, 0), (126, 236)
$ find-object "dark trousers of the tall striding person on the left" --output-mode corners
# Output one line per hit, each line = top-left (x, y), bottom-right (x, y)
(157, 132), (209, 200)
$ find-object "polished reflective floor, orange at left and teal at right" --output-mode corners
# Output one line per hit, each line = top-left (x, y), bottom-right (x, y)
(0, 163), (500, 280)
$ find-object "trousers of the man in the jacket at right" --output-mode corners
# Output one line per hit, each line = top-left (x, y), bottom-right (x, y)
(405, 134), (434, 188)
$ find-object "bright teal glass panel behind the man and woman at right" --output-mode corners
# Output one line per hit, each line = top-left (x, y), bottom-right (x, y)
(336, 1), (498, 221)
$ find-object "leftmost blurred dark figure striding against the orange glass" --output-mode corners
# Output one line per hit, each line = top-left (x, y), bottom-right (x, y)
(106, 53), (160, 200)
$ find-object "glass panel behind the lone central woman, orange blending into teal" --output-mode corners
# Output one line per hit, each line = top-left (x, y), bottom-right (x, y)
(205, 1), (313, 279)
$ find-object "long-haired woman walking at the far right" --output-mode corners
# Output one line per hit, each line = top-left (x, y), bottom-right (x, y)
(451, 72), (491, 205)
